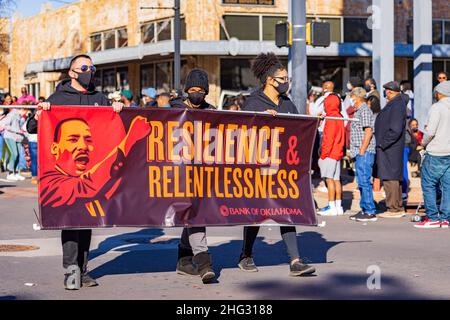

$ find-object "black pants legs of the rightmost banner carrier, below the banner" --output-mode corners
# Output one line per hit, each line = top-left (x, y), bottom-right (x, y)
(241, 226), (299, 261)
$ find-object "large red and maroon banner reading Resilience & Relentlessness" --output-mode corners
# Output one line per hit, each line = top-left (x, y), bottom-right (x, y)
(38, 106), (318, 229)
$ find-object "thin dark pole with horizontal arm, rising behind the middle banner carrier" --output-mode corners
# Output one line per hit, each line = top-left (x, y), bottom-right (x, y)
(141, 0), (181, 93)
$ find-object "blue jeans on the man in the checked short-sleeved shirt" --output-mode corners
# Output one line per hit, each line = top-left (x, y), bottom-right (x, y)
(356, 151), (376, 214)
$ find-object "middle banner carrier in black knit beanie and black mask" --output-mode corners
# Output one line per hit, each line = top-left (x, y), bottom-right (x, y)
(170, 69), (216, 284)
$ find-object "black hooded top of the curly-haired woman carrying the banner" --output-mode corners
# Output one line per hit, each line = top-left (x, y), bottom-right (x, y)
(242, 88), (298, 114)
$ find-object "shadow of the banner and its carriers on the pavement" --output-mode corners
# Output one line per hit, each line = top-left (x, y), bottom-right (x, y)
(90, 229), (369, 278)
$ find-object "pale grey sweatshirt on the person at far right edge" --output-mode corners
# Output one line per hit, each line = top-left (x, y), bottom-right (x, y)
(422, 97), (450, 157)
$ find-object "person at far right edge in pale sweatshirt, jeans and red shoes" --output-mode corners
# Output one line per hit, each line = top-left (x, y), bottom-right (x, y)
(415, 81), (450, 229)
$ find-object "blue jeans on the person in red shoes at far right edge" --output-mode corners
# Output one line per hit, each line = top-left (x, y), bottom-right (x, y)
(421, 154), (450, 221)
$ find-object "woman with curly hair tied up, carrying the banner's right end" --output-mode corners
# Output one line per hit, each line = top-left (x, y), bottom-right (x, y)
(238, 53), (315, 276)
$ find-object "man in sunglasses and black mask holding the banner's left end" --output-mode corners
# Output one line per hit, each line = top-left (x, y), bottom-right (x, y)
(35, 54), (123, 290)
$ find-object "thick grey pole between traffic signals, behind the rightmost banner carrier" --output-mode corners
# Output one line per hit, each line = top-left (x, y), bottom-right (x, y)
(289, 0), (308, 114)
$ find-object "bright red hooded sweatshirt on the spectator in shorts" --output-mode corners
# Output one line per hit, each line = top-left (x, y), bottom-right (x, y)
(320, 94), (345, 161)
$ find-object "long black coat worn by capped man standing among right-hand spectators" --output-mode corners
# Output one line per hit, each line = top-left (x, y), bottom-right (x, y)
(375, 95), (406, 181)
